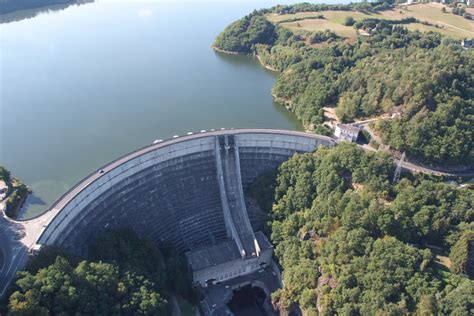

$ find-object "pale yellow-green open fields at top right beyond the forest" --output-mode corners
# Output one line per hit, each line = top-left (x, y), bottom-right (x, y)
(267, 3), (474, 40)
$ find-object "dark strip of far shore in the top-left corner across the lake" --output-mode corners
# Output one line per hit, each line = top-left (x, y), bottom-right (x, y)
(0, 0), (95, 24)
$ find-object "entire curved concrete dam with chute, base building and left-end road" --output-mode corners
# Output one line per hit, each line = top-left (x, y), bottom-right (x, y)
(0, 129), (335, 315)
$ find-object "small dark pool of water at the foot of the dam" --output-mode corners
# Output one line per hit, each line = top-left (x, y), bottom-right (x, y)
(227, 285), (267, 316)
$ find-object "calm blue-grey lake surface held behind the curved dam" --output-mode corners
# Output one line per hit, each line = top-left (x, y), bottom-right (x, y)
(0, 1), (340, 217)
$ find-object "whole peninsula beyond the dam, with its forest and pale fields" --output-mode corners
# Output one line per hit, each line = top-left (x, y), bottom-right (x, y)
(214, 1), (474, 166)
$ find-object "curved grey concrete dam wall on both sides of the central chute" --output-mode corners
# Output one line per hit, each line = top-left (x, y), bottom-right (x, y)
(37, 129), (335, 253)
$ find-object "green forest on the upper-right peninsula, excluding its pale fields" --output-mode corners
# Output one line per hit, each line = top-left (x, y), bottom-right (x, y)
(214, 3), (474, 164)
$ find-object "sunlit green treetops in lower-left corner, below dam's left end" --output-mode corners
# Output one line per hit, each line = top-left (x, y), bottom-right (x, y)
(9, 257), (166, 315)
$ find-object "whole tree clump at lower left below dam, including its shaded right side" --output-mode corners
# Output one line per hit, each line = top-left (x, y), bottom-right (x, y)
(5, 229), (194, 315)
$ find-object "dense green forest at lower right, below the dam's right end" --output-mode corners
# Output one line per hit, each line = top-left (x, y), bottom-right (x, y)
(253, 144), (474, 315)
